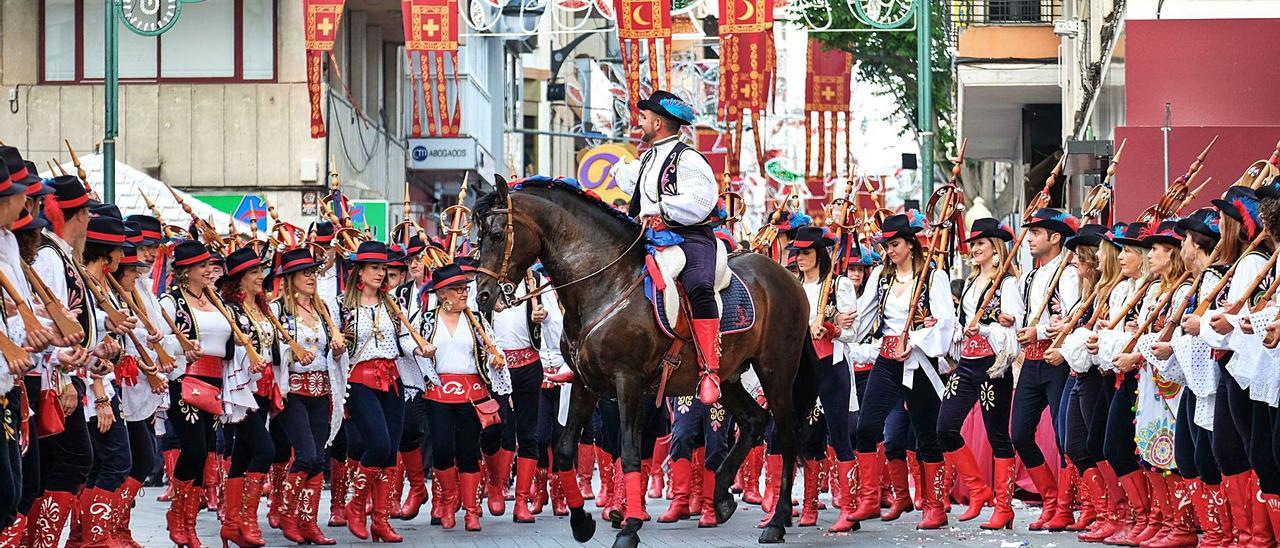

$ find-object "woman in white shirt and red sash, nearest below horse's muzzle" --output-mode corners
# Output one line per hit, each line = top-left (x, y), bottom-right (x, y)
(403, 264), (511, 531)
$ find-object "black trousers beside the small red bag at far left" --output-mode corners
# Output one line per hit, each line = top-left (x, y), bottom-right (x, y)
(40, 378), (93, 493)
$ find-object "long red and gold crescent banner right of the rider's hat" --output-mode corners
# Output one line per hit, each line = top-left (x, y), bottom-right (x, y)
(717, 0), (777, 175)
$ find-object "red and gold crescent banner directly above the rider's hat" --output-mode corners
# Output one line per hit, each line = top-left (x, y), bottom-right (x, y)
(613, 0), (672, 125)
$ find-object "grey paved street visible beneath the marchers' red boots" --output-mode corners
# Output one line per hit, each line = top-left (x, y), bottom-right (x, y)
(133, 488), (1084, 548)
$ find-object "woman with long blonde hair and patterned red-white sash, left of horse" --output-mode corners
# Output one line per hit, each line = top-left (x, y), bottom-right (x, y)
(271, 248), (347, 544)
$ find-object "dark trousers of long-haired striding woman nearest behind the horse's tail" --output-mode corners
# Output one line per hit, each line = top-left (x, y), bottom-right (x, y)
(858, 357), (942, 462)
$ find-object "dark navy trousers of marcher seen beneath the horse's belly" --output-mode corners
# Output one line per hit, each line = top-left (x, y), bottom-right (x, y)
(675, 396), (735, 470)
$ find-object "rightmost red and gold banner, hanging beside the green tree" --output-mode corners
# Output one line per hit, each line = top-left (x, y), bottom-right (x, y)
(804, 38), (854, 179)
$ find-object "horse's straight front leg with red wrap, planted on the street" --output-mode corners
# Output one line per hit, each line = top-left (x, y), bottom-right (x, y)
(613, 378), (648, 548)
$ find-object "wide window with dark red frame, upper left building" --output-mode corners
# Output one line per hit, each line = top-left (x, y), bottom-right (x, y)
(41, 0), (278, 83)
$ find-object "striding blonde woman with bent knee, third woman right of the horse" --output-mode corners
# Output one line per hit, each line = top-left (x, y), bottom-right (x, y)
(937, 219), (1024, 529)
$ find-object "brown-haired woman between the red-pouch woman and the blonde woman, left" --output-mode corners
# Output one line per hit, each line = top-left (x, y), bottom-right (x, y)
(218, 246), (280, 548)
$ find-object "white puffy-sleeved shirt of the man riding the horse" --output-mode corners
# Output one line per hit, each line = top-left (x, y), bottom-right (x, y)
(613, 136), (719, 224)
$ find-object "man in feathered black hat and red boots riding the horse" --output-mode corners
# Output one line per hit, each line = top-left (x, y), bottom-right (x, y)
(613, 90), (721, 405)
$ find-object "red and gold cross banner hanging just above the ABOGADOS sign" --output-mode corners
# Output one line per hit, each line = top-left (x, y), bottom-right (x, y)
(401, 0), (462, 137)
